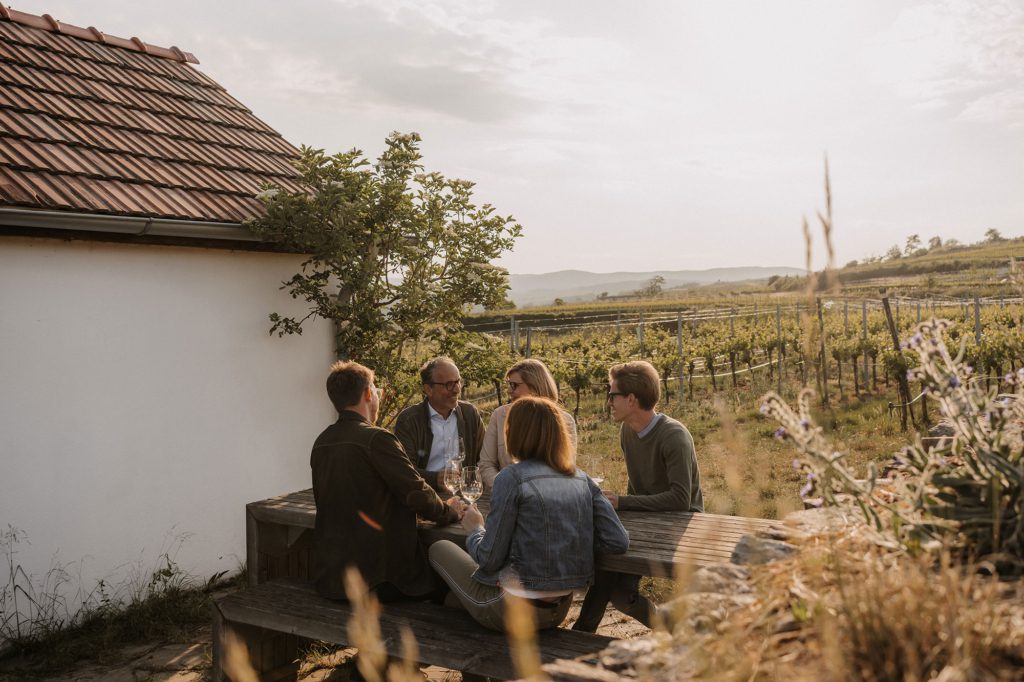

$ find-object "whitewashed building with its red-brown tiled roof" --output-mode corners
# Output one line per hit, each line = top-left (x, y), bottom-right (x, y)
(0, 5), (335, 626)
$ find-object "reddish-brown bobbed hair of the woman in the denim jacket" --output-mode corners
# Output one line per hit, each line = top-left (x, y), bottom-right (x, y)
(505, 395), (575, 475)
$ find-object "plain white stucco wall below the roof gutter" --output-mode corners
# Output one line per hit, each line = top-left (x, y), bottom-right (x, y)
(0, 237), (336, 614)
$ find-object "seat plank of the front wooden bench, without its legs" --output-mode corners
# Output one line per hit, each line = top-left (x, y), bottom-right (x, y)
(216, 579), (613, 679)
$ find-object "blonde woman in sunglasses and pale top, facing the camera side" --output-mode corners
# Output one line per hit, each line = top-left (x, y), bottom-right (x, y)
(477, 358), (577, 491)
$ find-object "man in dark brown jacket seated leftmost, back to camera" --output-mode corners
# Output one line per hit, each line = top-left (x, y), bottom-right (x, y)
(309, 363), (462, 601)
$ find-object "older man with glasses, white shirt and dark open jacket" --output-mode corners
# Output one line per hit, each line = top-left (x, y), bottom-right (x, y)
(394, 355), (483, 489)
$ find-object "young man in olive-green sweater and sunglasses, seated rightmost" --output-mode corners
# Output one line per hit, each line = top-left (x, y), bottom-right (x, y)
(572, 361), (703, 632)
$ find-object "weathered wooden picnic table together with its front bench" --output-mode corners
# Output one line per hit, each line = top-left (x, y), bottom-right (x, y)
(220, 488), (780, 680)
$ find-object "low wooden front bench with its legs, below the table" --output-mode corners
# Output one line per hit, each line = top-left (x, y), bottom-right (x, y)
(213, 579), (613, 682)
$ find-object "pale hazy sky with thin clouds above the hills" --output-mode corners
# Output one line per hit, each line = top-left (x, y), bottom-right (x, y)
(18, 0), (1024, 272)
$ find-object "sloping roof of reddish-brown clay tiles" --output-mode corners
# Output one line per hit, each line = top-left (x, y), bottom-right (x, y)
(0, 5), (298, 222)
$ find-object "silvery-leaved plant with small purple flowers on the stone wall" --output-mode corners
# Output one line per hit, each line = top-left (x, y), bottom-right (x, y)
(761, 319), (1024, 572)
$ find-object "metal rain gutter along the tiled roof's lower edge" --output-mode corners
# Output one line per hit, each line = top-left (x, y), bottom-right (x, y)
(0, 208), (261, 242)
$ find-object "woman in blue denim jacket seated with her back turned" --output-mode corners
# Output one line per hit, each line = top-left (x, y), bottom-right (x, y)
(429, 397), (629, 630)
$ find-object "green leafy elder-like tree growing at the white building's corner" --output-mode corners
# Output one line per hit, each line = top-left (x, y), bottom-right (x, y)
(249, 132), (521, 412)
